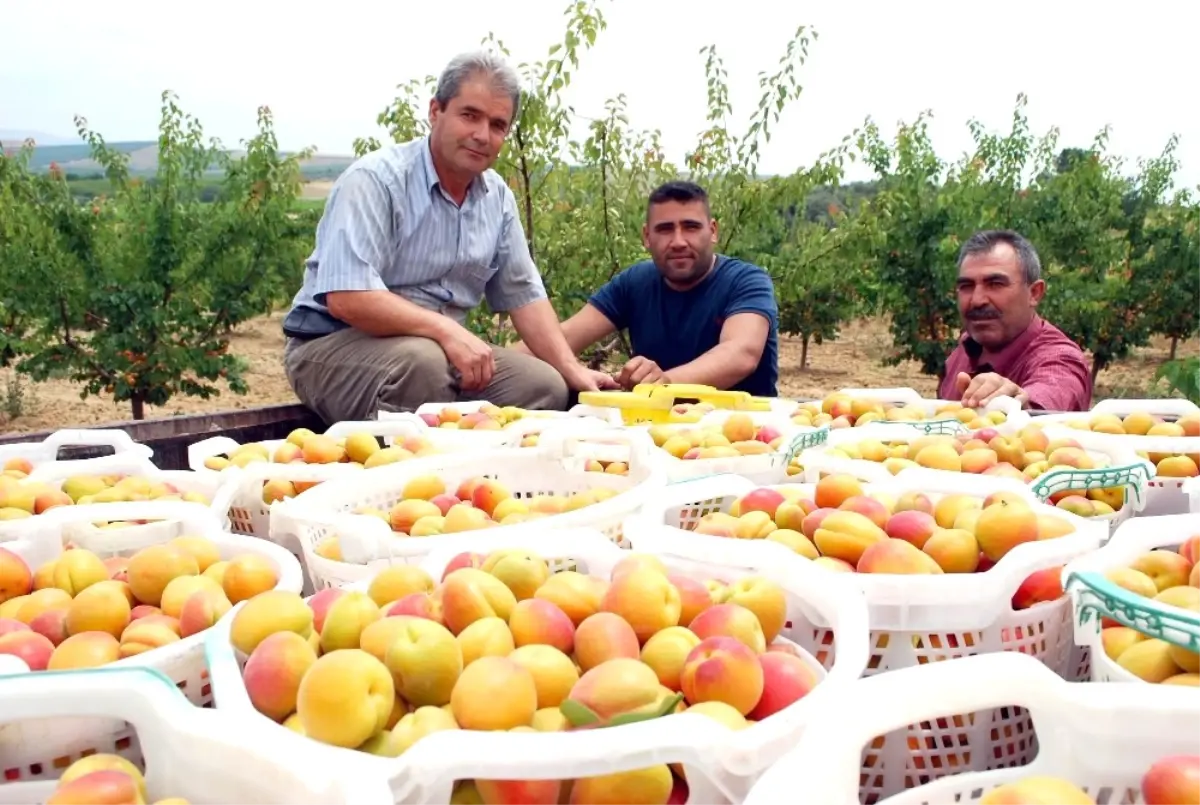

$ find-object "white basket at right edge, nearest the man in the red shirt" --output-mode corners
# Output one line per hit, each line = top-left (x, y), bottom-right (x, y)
(1037, 400), (1200, 515)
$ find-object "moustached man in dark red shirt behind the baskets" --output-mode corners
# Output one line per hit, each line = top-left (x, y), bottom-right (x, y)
(938, 230), (1092, 411)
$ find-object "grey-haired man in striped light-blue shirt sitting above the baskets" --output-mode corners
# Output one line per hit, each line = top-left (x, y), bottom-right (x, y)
(283, 53), (616, 422)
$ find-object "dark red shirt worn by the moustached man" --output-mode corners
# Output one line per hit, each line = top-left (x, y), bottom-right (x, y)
(938, 316), (1092, 411)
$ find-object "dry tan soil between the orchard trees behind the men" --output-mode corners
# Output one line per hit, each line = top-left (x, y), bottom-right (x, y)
(0, 313), (1200, 432)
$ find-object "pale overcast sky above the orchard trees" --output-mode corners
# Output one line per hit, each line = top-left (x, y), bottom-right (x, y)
(0, 0), (1200, 186)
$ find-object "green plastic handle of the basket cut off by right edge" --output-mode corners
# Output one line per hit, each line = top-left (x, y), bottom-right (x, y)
(1067, 572), (1200, 653)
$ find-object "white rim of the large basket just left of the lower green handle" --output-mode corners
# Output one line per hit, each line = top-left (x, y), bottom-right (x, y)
(625, 470), (1108, 633)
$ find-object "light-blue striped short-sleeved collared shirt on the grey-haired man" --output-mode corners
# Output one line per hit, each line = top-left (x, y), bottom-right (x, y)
(283, 137), (546, 336)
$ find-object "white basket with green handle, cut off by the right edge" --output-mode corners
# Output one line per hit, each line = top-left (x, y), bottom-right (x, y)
(1063, 515), (1200, 684)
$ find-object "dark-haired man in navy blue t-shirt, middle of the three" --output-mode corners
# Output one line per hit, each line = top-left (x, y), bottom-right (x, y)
(535, 181), (779, 397)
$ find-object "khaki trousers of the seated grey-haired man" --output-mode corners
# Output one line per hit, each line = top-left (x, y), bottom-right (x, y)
(283, 328), (568, 423)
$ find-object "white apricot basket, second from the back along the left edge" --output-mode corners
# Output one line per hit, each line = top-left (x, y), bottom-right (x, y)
(0, 456), (240, 542)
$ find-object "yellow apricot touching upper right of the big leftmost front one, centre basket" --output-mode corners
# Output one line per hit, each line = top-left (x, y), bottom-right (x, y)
(384, 615), (463, 707)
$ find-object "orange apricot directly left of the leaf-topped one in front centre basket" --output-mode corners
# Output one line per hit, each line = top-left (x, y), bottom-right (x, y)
(450, 657), (537, 729)
